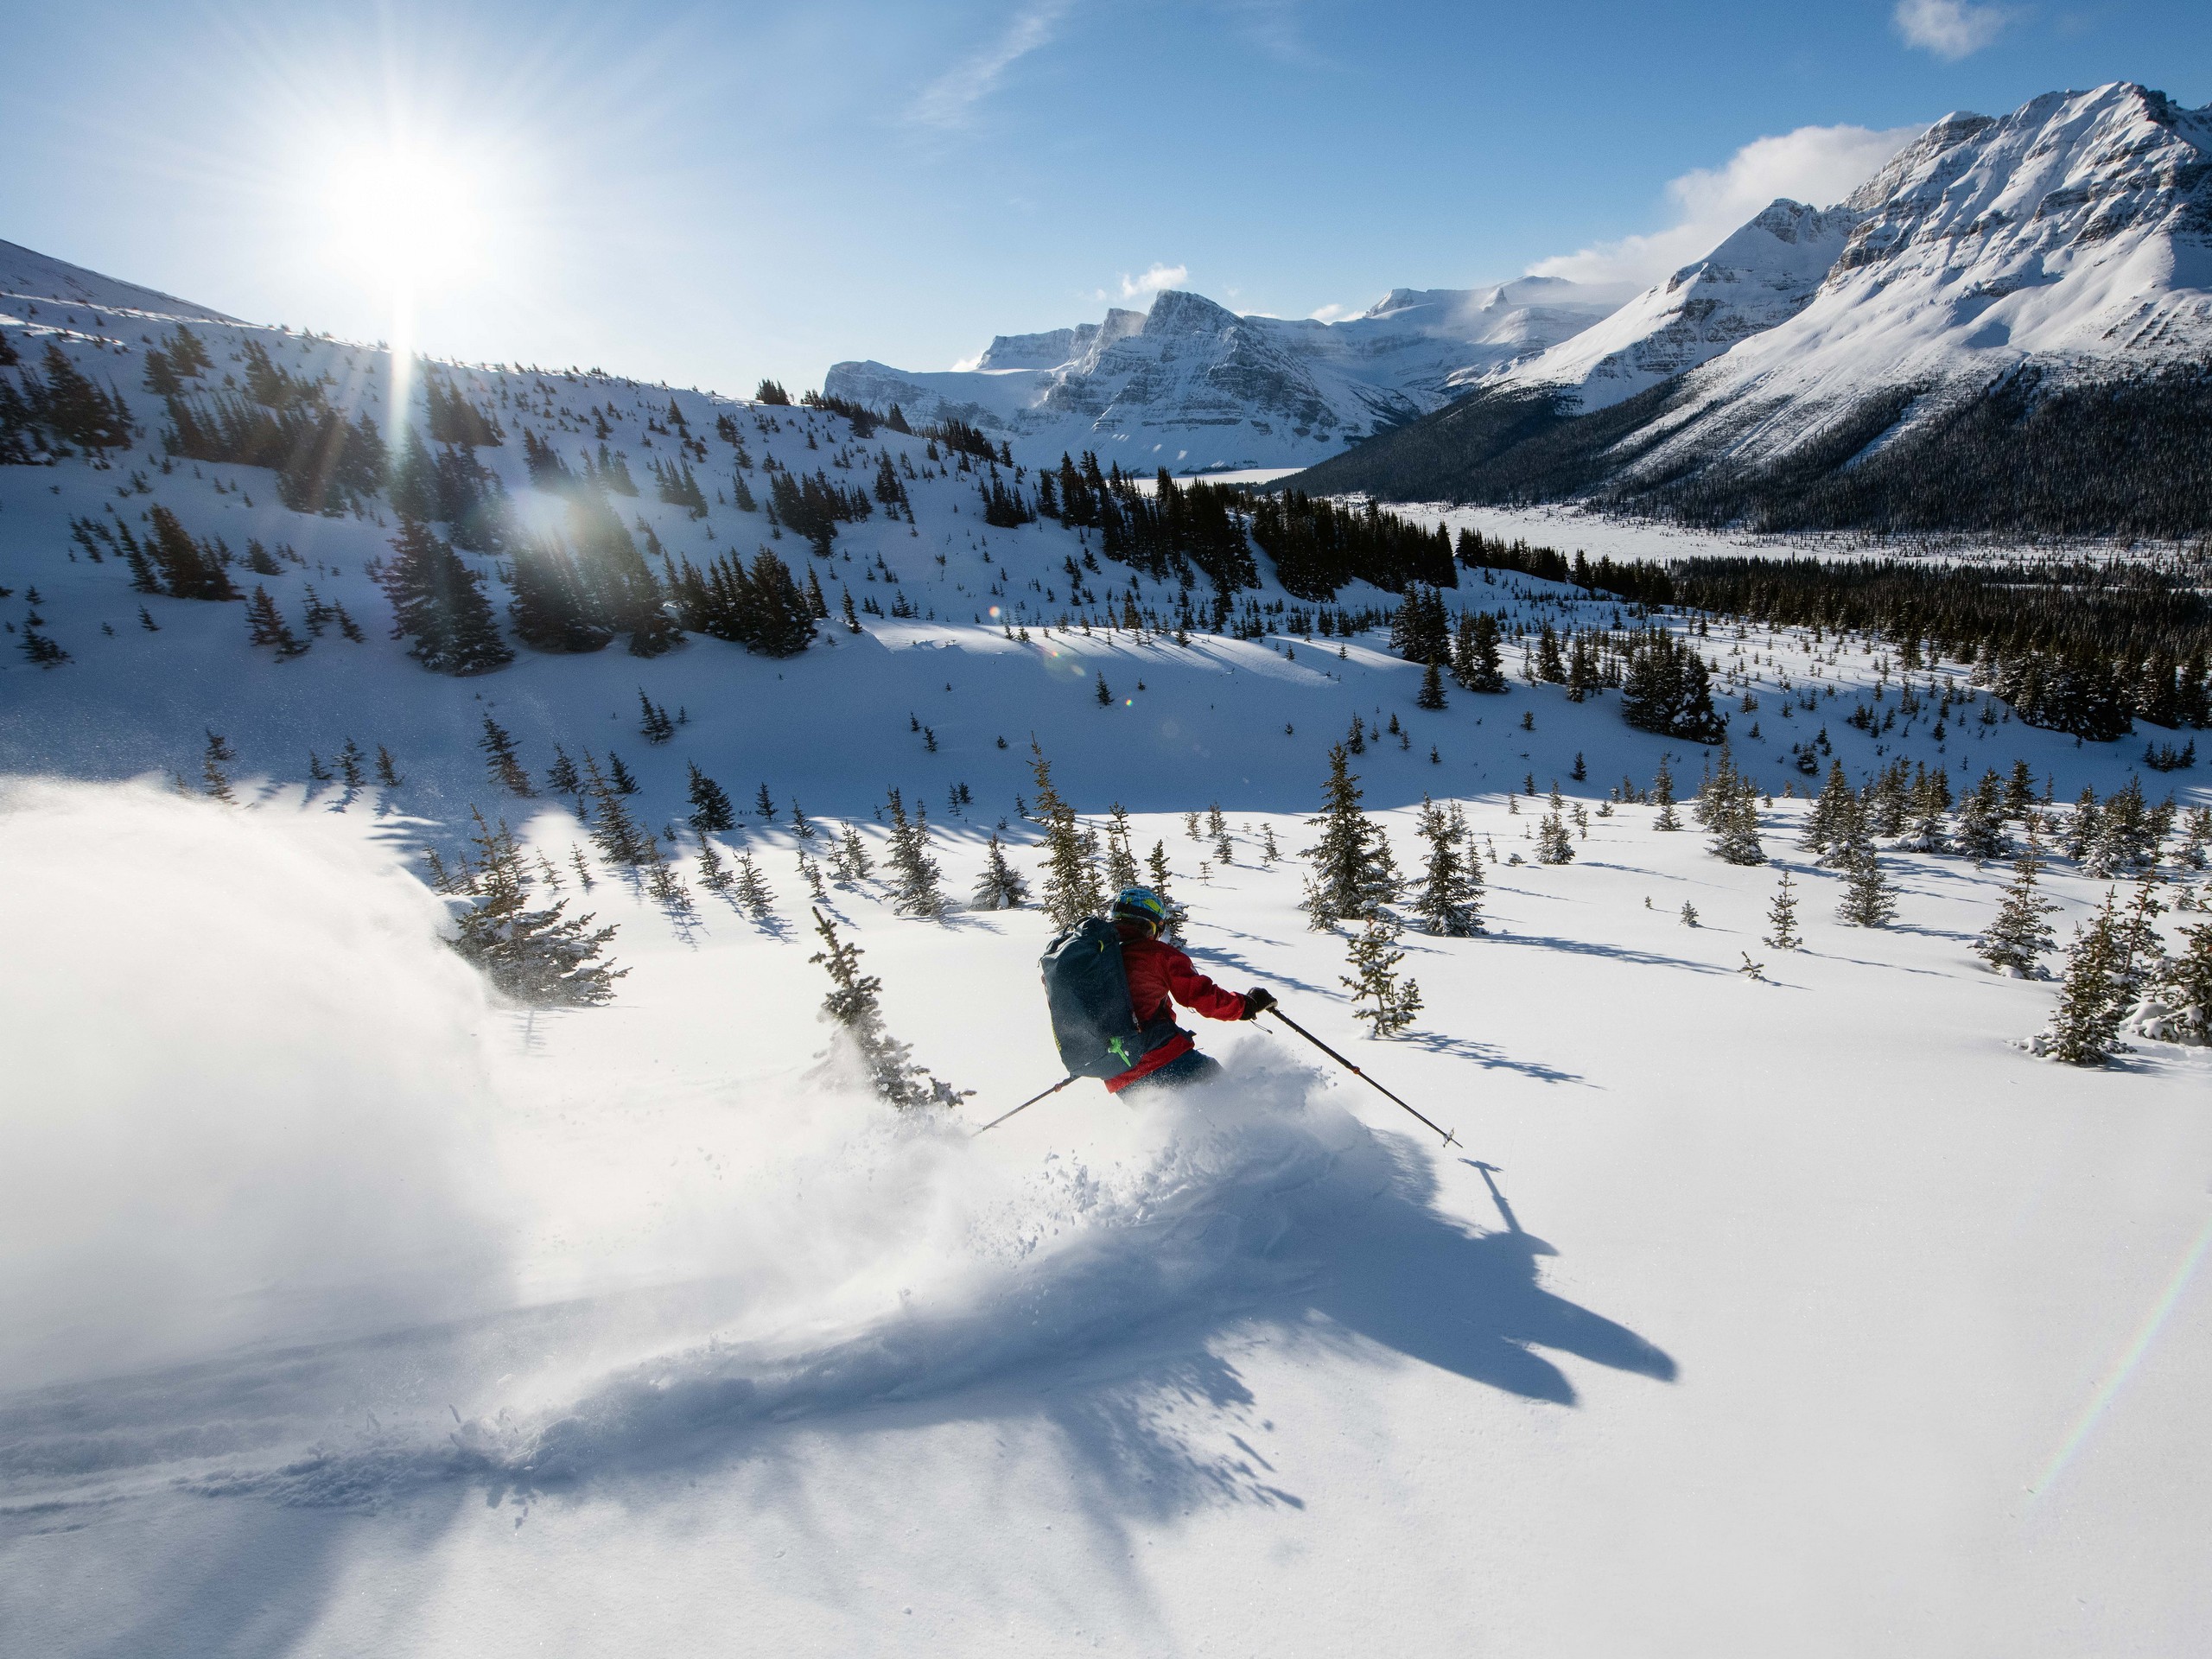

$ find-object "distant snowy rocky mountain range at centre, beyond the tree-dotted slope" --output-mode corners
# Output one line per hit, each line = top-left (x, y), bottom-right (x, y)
(823, 276), (1628, 474)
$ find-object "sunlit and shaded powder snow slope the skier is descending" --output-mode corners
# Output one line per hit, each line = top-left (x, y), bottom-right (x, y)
(0, 253), (2212, 1656)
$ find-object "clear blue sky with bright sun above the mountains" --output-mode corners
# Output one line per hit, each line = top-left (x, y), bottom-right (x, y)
(0, 0), (2212, 391)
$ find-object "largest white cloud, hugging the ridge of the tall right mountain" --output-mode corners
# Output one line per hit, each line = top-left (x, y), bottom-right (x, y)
(1529, 126), (1920, 283)
